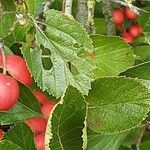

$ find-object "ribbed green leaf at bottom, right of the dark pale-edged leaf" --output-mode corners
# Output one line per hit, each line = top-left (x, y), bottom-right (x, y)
(87, 130), (127, 150)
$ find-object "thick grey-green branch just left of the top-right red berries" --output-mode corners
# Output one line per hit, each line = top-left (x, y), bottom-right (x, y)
(102, 0), (116, 35)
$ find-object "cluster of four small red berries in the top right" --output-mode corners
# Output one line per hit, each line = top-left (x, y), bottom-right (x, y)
(113, 7), (143, 44)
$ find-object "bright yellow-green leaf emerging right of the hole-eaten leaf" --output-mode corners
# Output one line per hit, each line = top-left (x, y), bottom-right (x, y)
(91, 35), (134, 78)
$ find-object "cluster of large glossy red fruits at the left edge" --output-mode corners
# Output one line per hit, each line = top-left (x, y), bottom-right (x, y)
(0, 49), (33, 112)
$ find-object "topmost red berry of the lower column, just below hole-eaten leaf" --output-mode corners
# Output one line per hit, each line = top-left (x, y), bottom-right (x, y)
(33, 91), (49, 104)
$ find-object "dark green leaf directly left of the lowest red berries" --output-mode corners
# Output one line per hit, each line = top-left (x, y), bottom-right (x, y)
(4, 123), (36, 150)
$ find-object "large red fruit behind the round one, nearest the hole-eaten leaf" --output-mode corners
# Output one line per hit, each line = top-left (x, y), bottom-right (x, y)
(6, 55), (33, 86)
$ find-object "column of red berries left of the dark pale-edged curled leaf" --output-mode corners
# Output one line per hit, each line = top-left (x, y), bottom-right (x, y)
(26, 91), (56, 150)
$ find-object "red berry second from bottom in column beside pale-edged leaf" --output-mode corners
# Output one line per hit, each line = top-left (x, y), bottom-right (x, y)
(26, 117), (47, 134)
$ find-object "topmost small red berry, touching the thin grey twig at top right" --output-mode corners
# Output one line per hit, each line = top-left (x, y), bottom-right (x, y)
(125, 7), (138, 20)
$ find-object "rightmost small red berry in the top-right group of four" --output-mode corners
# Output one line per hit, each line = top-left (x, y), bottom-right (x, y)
(129, 24), (143, 37)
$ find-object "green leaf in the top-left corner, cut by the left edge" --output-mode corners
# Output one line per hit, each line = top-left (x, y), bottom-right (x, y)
(0, 0), (16, 38)
